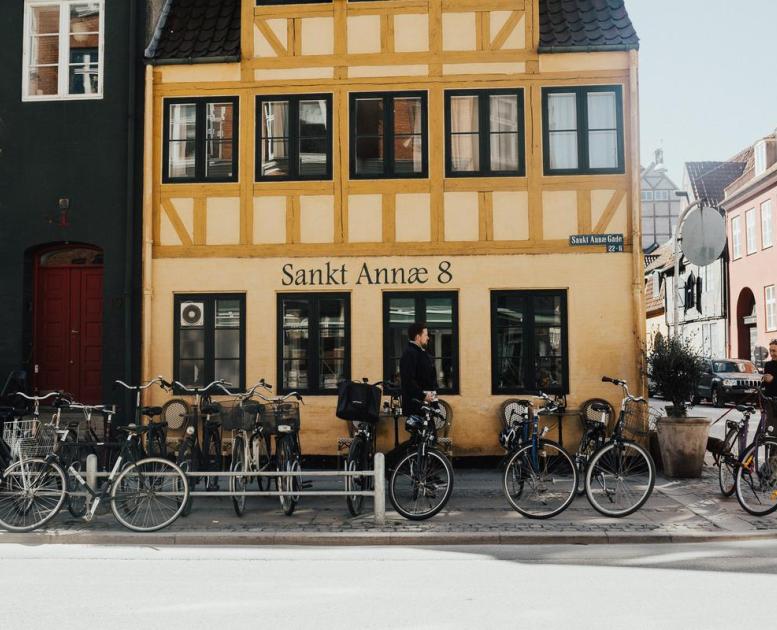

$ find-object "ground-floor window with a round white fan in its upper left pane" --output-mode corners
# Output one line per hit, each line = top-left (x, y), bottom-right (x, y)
(173, 294), (246, 390)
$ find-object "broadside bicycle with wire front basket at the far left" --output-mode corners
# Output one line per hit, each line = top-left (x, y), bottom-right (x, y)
(0, 397), (189, 532)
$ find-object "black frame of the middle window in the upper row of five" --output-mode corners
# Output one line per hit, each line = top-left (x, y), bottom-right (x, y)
(348, 90), (429, 180)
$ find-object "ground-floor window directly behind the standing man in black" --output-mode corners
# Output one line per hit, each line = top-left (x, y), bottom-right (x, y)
(383, 292), (459, 394)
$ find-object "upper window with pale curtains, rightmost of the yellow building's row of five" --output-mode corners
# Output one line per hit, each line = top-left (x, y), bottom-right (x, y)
(542, 85), (625, 175)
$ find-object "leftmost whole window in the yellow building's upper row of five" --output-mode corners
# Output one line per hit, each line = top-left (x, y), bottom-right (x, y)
(162, 96), (238, 183)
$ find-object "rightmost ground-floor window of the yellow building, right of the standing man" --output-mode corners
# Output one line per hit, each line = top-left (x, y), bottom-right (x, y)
(491, 291), (569, 394)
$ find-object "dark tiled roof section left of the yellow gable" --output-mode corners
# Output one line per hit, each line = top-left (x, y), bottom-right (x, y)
(146, 0), (240, 62)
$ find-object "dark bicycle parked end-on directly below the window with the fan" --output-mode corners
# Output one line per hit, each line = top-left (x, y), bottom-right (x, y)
(174, 380), (230, 516)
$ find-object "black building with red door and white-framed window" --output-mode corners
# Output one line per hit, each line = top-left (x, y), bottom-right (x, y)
(0, 0), (145, 402)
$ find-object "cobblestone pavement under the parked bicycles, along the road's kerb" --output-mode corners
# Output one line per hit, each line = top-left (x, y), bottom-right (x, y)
(0, 460), (777, 544)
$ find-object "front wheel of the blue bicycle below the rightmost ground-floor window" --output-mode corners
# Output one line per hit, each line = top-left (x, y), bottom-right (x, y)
(502, 440), (577, 519)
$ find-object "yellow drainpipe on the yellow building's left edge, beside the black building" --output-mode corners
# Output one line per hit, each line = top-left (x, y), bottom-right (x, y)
(140, 65), (154, 404)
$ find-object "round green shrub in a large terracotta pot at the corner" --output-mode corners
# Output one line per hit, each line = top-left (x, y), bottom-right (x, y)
(648, 337), (710, 477)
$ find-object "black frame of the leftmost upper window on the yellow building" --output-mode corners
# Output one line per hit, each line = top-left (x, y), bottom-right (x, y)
(162, 96), (240, 184)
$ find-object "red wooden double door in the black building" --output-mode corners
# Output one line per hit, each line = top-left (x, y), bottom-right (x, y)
(35, 266), (103, 403)
